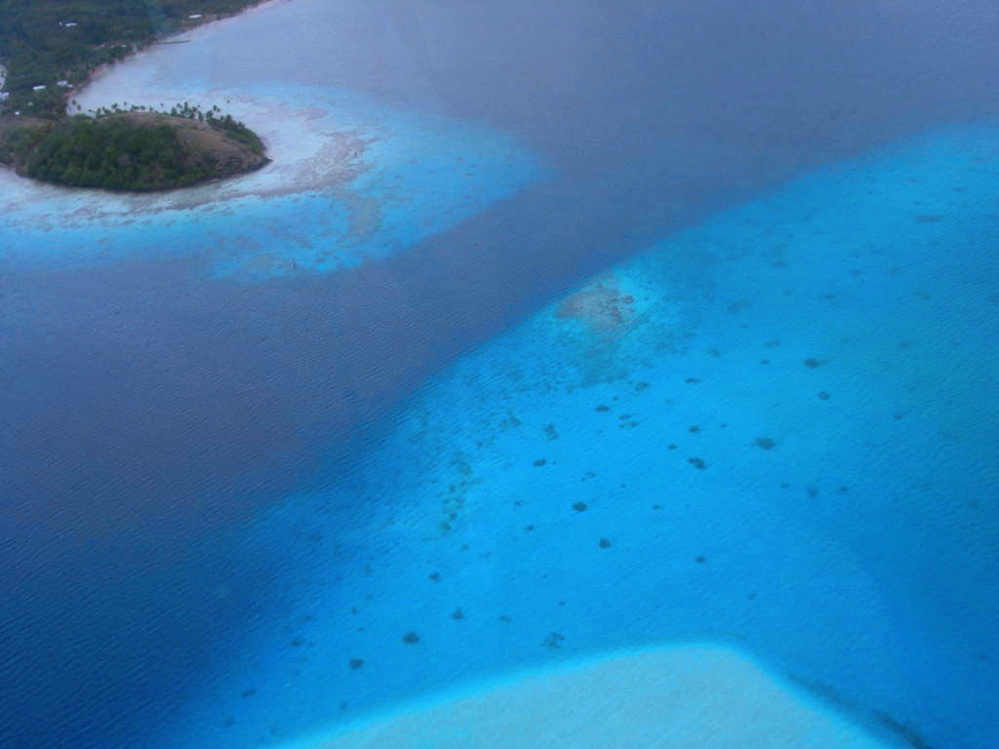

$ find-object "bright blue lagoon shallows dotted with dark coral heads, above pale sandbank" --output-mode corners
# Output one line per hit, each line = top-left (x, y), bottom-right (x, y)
(160, 127), (999, 749)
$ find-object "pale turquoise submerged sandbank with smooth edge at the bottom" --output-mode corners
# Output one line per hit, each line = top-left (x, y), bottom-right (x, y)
(289, 646), (886, 749)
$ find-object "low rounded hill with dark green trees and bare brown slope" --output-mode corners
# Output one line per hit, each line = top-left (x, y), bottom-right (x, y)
(0, 111), (270, 192)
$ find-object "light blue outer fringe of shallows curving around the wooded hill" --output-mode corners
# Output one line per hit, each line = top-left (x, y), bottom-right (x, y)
(0, 81), (545, 280)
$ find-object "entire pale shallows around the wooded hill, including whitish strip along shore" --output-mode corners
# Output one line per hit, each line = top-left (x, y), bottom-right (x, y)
(0, 7), (544, 281)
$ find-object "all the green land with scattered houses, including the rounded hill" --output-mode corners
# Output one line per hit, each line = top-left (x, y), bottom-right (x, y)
(0, 0), (270, 192)
